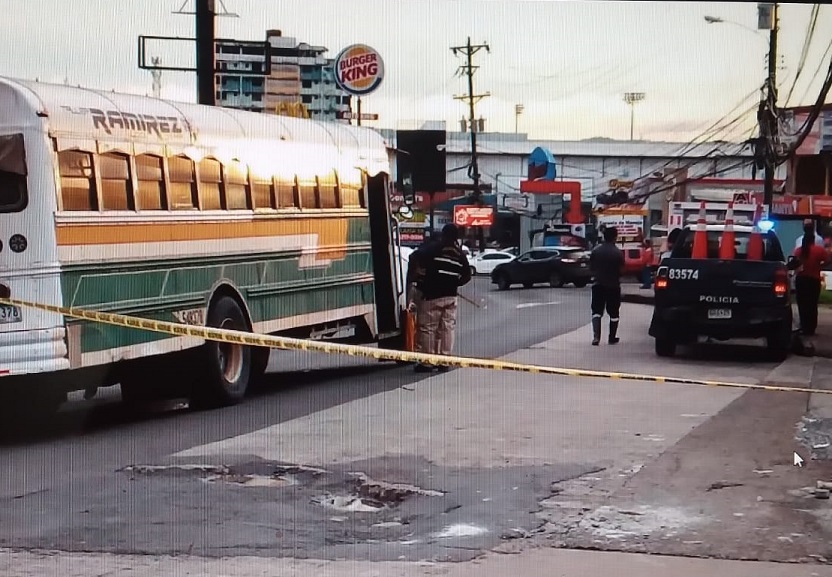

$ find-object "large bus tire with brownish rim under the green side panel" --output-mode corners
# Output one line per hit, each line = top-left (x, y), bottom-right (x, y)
(191, 296), (253, 409)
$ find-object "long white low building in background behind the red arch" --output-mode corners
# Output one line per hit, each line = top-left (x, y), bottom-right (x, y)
(379, 123), (786, 246)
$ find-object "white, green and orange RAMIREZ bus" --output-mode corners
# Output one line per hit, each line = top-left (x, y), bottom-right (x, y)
(0, 78), (404, 414)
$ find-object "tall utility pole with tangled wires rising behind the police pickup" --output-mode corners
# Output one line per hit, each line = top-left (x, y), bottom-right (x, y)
(757, 2), (780, 207)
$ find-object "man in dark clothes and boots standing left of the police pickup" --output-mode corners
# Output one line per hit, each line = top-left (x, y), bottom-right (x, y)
(589, 226), (624, 347)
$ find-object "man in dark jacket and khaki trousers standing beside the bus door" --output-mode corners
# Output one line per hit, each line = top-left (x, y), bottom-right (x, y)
(413, 224), (471, 373)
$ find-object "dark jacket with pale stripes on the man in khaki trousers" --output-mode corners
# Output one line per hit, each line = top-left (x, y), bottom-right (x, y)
(408, 241), (471, 300)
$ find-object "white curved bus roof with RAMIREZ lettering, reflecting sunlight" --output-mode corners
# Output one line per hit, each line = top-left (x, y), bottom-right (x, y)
(0, 76), (390, 176)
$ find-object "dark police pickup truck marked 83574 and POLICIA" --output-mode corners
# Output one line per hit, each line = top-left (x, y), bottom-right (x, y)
(649, 225), (792, 358)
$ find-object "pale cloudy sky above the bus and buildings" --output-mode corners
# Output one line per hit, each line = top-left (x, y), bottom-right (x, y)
(0, 0), (832, 142)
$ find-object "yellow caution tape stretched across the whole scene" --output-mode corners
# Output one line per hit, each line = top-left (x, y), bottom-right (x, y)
(0, 298), (832, 394)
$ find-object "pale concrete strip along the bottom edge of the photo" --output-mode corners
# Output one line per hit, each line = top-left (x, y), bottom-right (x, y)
(0, 548), (832, 577)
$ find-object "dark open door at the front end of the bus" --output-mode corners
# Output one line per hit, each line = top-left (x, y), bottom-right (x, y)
(367, 173), (404, 338)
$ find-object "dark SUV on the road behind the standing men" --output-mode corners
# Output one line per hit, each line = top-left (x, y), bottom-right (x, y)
(491, 247), (592, 290)
